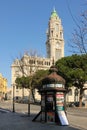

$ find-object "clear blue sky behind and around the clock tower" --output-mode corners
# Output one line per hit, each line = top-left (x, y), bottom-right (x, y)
(0, 0), (87, 87)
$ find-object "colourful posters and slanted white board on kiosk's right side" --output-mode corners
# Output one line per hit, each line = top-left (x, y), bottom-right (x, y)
(56, 92), (69, 125)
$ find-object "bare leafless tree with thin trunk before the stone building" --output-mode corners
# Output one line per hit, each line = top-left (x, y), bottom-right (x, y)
(14, 51), (38, 115)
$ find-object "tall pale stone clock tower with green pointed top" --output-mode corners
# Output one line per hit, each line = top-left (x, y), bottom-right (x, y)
(46, 9), (64, 62)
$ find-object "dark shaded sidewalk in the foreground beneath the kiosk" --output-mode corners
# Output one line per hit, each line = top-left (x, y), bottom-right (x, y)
(0, 109), (81, 130)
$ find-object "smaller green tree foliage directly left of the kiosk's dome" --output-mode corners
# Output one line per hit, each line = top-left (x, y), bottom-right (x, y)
(15, 70), (48, 90)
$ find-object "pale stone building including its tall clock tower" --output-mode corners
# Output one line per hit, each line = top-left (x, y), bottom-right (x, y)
(11, 9), (64, 99)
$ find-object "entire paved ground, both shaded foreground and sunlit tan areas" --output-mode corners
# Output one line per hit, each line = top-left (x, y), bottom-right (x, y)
(0, 102), (87, 130)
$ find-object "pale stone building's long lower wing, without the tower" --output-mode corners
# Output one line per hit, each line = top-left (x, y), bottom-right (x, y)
(11, 54), (52, 99)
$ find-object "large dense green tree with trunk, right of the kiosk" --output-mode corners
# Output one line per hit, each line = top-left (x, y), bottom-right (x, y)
(56, 54), (87, 106)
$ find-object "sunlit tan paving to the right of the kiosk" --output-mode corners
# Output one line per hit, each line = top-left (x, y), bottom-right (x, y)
(67, 108), (87, 130)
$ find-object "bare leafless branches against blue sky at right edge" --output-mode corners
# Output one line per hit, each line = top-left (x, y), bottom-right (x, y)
(70, 11), (87, 54)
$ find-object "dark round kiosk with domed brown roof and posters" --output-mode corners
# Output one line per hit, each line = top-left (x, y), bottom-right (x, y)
(33, 66), (69, 125)
